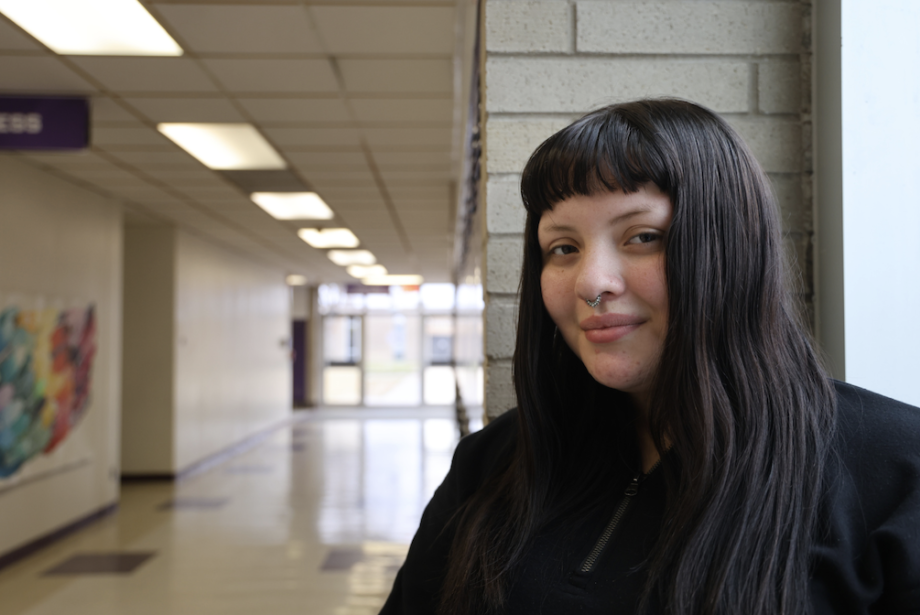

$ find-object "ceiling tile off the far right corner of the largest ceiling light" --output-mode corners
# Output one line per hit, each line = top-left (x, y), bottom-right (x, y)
(202, 59), (339, 92)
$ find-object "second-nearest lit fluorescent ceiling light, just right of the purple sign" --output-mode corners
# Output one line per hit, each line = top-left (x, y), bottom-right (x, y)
(157, 124), (287, 171)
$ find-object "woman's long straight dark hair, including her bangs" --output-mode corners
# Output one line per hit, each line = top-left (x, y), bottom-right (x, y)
(441, 99), (835, 615)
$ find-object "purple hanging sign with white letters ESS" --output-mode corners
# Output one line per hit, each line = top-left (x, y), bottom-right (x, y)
(0, 96), (89, 150)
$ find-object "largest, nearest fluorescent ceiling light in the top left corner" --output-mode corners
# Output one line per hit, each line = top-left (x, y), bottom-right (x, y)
(0, 0), (182, 56)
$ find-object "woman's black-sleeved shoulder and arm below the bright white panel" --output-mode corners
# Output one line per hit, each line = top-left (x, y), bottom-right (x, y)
(812, 382), (920, 613)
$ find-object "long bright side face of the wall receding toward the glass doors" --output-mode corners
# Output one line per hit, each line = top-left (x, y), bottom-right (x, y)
(174, 231), (292, 470)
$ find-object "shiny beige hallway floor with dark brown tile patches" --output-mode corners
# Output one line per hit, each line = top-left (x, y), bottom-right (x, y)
(0, 408), (475, 615)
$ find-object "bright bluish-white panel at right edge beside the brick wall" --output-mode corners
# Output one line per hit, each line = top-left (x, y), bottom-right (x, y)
(840, 0), (920, 405)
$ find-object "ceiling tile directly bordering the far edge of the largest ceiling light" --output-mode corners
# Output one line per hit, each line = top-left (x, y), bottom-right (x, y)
(70, 56), (217, 92)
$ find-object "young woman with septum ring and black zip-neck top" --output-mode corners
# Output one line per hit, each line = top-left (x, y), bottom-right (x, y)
(382, 100), (920, 615)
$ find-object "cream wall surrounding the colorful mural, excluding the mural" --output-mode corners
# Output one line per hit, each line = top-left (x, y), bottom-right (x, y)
(0, 155), (122, 554)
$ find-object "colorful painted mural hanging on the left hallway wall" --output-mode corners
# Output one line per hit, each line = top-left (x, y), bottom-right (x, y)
(0, 305), (96, 478)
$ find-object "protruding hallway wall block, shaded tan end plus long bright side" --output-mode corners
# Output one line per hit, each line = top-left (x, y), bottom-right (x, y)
(122, 226), (291, 475)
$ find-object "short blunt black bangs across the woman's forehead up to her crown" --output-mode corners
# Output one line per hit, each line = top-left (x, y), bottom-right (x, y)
(521, 99), (687, 216)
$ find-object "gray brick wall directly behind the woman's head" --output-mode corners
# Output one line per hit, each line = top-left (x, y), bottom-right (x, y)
(483, 0), (813, 417)
